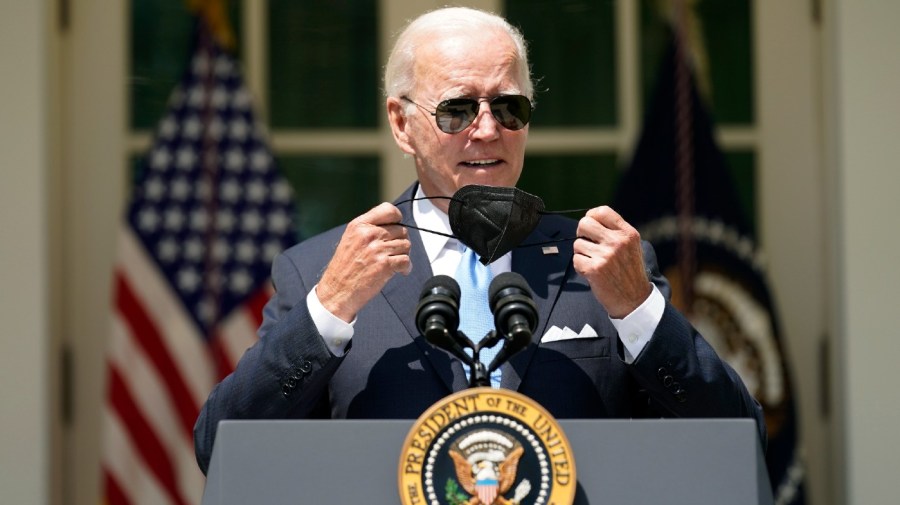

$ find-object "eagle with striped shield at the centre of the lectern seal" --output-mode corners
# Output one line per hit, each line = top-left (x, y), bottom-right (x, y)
(448, 430), (531, 505)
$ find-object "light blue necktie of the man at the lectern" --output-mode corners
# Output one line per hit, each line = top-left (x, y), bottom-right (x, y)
(454, 246), (500, 388)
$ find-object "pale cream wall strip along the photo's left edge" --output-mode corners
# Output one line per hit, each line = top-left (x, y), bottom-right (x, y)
(0, 0), (50, 504)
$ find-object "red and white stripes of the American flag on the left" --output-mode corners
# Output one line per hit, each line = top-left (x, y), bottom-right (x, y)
(104, 228), (273, 505)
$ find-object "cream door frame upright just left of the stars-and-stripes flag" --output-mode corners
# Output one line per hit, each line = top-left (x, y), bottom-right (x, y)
(57, 0), (129, 504)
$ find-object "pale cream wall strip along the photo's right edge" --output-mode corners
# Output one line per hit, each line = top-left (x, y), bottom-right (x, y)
(825, 0), (900, 504)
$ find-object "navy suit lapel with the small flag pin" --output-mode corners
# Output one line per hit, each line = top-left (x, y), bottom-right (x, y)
(501, 219), (572, 390)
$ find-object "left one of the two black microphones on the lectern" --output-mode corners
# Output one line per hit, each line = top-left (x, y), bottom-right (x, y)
(416, 275), (472, 363)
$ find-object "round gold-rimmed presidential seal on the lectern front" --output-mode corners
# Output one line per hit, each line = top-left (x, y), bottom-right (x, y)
(398, 387), (576, 505)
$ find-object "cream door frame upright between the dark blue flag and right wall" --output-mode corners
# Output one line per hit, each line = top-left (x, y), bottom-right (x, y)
(751, 2), (828, 505)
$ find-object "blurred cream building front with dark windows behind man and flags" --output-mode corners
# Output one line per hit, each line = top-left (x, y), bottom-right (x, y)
(0, 0), (900, 505)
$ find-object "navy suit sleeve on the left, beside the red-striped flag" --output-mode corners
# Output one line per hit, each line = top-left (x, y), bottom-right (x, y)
(194, 254), (342, 473)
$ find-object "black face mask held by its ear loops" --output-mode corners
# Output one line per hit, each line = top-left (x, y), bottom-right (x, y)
(399, 185), (586, 265)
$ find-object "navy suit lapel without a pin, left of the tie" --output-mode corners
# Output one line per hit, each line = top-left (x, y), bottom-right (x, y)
(382, 184), (466, 391)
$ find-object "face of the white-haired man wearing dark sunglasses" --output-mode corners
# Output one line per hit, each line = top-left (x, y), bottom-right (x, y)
(388, 30), (528, 211)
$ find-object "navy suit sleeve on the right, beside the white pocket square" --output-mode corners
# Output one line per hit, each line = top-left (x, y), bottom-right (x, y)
(618, 244), (767, 447)
